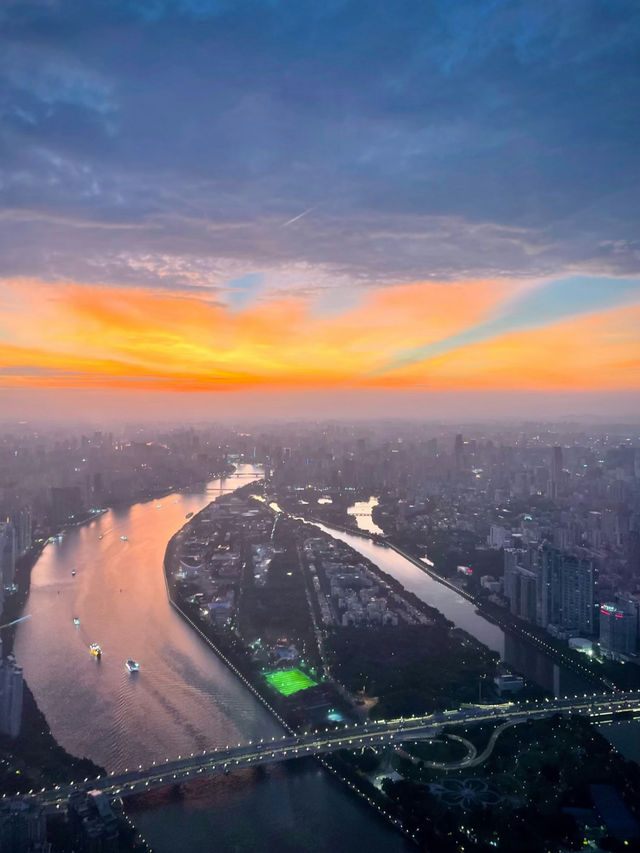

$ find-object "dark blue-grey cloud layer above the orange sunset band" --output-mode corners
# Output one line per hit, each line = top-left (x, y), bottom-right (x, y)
(0, 0), (640, 287)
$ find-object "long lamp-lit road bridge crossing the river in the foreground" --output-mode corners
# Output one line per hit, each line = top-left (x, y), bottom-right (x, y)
(15, 691), (640, 811)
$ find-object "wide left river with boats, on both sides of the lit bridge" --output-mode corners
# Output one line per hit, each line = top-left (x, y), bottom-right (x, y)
(15, 465), (406, 853)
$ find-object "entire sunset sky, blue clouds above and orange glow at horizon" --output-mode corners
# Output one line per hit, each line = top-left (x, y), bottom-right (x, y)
(0, 0), (640, 417)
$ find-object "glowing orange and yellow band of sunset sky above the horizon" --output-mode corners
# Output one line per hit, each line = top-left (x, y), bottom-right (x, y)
(0, 272), (640, 420)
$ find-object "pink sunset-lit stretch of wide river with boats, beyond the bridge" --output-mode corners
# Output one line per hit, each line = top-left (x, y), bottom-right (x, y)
(16, 466), (278, 770)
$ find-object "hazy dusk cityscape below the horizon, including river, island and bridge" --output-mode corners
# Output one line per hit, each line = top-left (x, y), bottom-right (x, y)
(0, 420), (640, 851)
